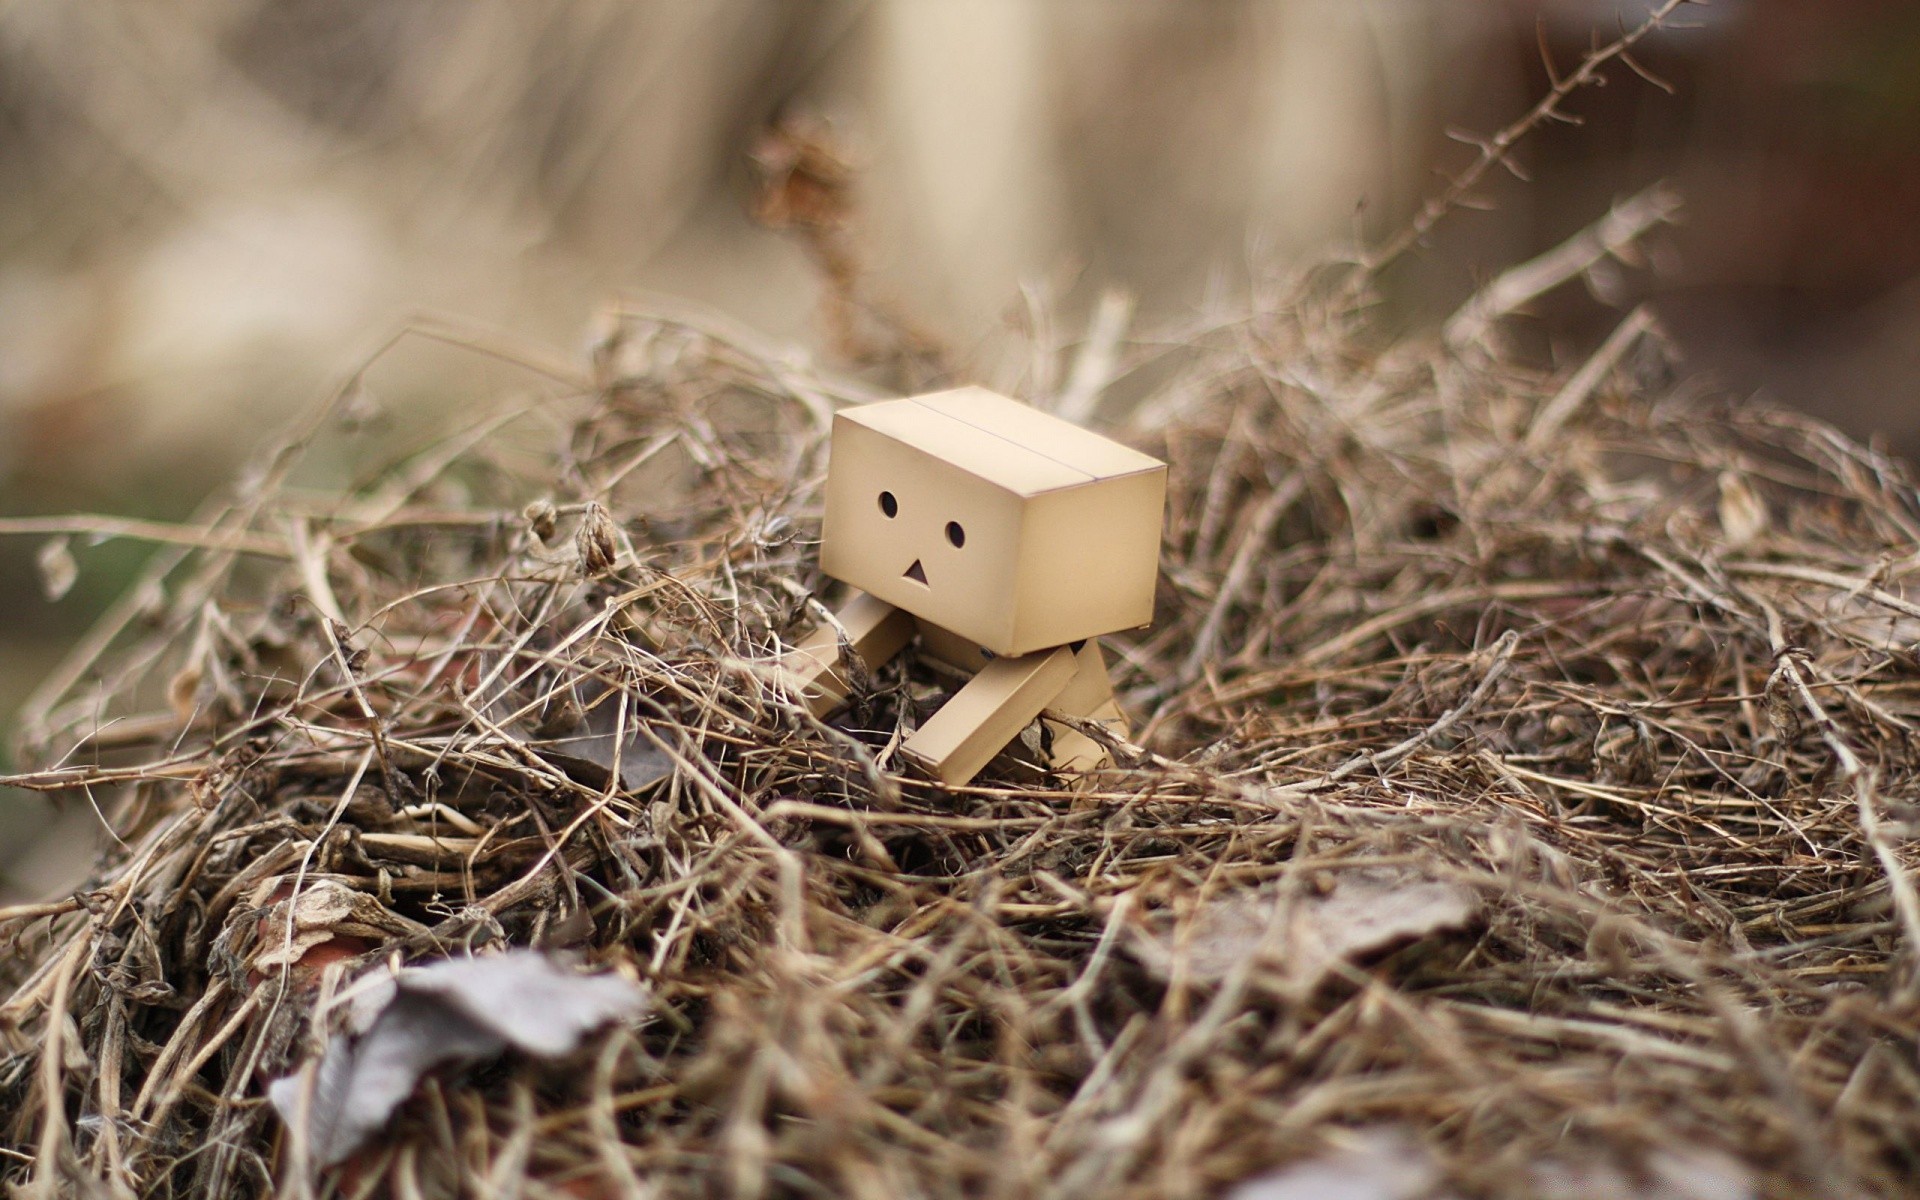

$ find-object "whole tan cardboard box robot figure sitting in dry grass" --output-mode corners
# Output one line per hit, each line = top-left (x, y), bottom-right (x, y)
(783, 388), (1167, 783)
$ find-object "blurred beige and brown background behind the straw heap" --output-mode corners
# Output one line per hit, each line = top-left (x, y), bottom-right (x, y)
(0, 0), (1920, 902)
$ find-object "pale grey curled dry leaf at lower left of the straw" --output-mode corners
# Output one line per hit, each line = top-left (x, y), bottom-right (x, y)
(267, 950), (647, 1167)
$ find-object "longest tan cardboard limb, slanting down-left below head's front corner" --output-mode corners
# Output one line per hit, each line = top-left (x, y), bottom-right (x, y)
(900, 647), (1075, 783)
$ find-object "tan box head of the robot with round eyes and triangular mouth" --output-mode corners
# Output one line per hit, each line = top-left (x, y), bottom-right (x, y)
(820, 388), (1167, 655)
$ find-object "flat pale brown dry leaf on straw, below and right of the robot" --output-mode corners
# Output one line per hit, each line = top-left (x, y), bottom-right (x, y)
(1135, 872), (1478, 993)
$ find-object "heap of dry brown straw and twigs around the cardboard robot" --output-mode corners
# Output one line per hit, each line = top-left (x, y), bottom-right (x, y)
(0, 213), (1920, 1198)
